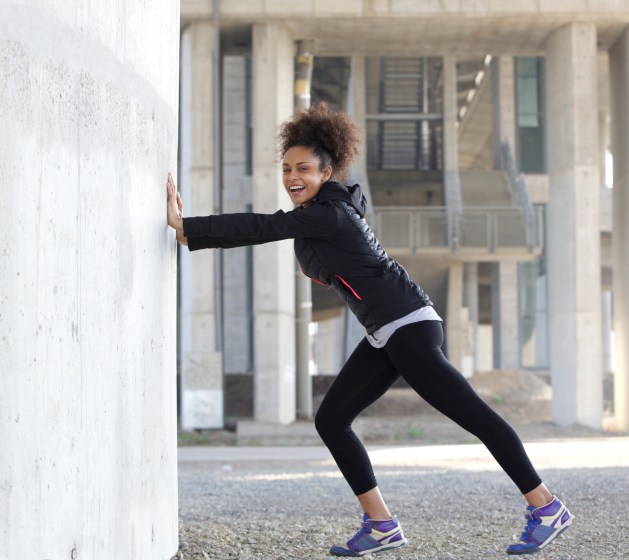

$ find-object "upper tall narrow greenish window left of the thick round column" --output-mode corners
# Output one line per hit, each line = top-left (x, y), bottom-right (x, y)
(515, 57), (546, 173)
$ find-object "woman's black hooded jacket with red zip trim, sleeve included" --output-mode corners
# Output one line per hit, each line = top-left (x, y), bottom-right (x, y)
(183, 181), (432, 334)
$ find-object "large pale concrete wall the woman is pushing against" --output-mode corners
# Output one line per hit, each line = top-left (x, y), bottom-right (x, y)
(0, 0), (179, 560)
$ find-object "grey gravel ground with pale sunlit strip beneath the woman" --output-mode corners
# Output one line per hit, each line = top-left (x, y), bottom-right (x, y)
(176, 438), (629, 560)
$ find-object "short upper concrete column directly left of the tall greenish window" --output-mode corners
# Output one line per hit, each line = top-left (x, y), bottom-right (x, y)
(491, 56), (516, 169)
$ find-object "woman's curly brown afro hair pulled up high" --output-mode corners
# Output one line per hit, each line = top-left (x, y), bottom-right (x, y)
(277, 101), (361, 181)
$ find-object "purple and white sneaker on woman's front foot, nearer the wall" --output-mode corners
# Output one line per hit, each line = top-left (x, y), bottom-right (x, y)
(330, 514), (407, 556)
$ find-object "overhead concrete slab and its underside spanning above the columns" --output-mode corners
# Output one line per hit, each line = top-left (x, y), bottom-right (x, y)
(181, 0), (629, 56)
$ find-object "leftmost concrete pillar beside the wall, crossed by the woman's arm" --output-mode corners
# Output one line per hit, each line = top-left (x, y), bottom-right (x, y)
(179, 21), (223, 430)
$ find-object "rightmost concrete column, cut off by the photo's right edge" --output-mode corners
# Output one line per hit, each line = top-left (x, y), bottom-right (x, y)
(609, 29), (629, 431)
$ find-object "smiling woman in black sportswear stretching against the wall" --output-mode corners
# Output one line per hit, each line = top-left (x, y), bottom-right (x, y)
(167, 103), (574, 556)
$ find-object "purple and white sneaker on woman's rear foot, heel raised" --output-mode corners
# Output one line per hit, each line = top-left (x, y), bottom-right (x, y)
(507, 496), (574, 554)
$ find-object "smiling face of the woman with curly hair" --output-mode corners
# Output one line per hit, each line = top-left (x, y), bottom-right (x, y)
(282, 146), (332, 206)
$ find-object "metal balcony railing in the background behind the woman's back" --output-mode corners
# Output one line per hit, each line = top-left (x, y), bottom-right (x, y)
(374, 206), (544, 253)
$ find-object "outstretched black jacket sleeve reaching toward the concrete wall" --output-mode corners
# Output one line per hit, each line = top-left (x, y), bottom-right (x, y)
(183, 204), (337, 251)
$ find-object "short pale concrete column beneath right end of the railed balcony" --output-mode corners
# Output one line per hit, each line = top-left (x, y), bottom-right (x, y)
(491, 261), (520, 370)
